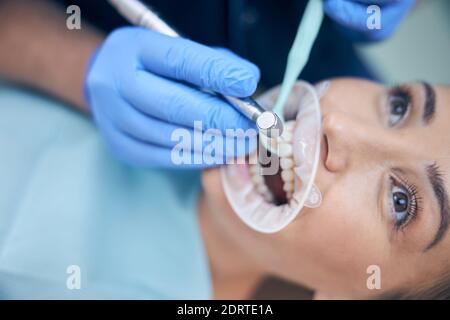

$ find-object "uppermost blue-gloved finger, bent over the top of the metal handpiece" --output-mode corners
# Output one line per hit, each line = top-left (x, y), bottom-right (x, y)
(138, 30), (260, 97)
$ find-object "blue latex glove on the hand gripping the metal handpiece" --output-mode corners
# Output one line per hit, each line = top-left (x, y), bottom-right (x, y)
(85, 27), (259, 168)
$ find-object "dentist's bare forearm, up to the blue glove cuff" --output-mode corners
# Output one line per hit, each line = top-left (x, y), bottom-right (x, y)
(0, 0), (103, 111)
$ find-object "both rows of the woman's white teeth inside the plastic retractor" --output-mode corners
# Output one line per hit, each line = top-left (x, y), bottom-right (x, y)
(250, 121), (295, 201)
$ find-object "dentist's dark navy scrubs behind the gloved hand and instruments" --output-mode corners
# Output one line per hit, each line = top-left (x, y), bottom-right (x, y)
(51, 0), (376, 88)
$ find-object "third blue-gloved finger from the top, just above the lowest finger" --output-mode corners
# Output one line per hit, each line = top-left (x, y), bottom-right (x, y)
(94, 94), (256, 157)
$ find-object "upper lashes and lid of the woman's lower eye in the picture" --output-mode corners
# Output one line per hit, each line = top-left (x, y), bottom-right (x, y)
(391, 176), (422, 231)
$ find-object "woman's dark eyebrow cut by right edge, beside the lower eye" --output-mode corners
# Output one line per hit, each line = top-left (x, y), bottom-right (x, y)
(425, 164), (450, 251)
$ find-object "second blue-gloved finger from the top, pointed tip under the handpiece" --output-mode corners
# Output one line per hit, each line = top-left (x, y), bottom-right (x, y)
(122, 70), (255, 134)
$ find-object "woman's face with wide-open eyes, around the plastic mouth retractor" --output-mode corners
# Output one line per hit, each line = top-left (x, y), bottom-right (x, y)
(203, 79), (450, 297)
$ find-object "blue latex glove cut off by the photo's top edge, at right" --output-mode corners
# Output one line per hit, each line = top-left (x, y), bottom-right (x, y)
(325, 0), (415, 41)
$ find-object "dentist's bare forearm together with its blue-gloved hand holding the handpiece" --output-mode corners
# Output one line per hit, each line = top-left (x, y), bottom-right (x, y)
(0, 0), (259, 168)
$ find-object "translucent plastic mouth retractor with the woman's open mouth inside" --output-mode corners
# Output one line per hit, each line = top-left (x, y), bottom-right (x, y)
(221, 81), (322, 233)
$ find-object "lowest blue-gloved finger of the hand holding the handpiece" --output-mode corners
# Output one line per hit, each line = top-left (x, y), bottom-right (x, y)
(97, 110), (216, 169)
